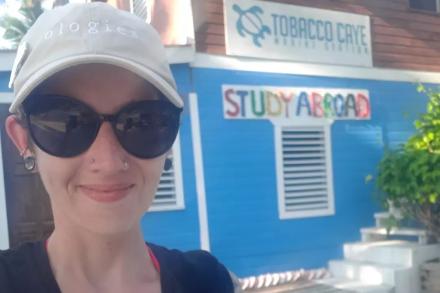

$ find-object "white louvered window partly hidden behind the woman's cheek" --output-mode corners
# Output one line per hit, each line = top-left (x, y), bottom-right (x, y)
(150, 133), (184, 211)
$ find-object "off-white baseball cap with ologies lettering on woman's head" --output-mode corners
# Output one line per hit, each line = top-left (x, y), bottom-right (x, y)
(9, 2), (183, 113)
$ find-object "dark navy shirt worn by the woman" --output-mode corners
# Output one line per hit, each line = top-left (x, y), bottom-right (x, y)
(0, 241), (234, 293)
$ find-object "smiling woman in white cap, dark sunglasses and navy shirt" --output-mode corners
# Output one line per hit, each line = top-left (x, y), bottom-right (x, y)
(0, 2), (233, 293)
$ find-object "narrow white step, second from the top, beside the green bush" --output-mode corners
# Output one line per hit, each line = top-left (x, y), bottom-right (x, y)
(361, 227), (429, 244)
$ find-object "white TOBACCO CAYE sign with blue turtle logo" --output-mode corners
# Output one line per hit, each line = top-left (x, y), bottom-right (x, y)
(224, 0), (372, 66)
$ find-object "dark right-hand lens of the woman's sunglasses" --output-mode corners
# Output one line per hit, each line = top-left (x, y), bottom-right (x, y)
(115, 101), (180, 159)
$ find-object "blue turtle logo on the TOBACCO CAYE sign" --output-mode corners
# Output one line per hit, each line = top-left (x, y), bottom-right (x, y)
(232, 4), (270, 47)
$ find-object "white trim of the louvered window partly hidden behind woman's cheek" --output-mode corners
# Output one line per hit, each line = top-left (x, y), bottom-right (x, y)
(148, 132), (185, 212)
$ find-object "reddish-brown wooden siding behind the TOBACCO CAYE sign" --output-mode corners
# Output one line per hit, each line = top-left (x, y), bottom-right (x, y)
(193, 0), (440, 72)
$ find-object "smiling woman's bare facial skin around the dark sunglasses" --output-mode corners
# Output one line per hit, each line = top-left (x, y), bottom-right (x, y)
(21, 64), (166, 234)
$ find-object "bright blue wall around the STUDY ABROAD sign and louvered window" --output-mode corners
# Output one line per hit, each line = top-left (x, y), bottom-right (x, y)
(193, 68), (426, 276)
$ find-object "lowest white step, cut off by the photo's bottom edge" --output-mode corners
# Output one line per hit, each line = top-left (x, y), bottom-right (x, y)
(317, 278), (394, 293)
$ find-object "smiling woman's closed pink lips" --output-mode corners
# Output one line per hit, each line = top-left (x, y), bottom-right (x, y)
(79, 184), (134, 203)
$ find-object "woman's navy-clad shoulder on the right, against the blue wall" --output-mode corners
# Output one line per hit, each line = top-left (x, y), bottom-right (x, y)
(148, 243), (234, 293)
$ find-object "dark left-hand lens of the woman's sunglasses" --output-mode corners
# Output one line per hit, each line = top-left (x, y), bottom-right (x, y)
(28, 96), (99, 157)
